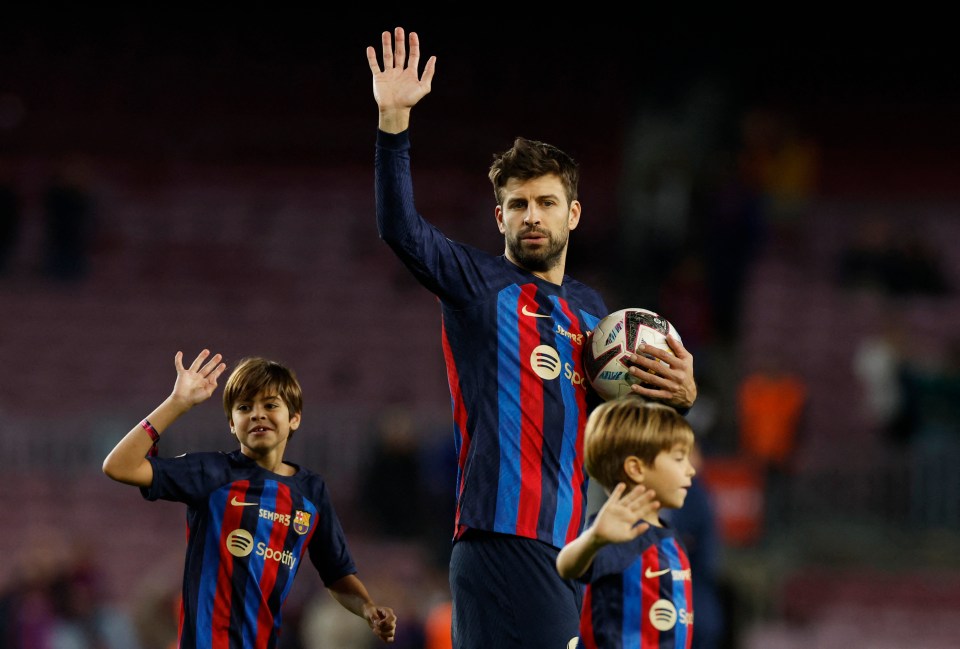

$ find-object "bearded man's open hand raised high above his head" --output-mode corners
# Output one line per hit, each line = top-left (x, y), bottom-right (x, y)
(367, 27), (437, 133)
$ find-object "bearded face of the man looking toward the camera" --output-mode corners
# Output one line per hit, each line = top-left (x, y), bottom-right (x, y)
(496, 174), (580, 273)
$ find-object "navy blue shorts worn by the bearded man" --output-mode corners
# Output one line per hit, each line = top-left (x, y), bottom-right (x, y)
(450, 530), (583, 649)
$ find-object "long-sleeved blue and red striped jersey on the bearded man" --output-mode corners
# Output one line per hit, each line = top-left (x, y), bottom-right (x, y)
(376, 131), (607, 548)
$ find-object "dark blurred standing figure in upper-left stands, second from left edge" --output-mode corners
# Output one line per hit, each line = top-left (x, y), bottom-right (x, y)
(43, 159), (96, 280)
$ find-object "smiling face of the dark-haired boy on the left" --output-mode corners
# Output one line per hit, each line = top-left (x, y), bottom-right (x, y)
(230, 391), (300, 456)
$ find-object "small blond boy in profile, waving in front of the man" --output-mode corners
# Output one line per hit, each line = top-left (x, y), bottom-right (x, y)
(557, 396), (696, 649)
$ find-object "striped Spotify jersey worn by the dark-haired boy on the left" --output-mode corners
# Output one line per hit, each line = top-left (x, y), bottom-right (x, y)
(141, 450), (356, 649)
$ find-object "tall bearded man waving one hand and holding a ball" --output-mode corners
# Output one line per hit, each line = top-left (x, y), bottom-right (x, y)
(367, 27), (696, 649)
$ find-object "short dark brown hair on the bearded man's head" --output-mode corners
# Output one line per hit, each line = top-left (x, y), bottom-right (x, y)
(487, 137), (580, 205)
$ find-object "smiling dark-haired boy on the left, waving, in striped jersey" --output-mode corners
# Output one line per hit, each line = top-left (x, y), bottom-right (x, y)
(103, 349), (397, 649)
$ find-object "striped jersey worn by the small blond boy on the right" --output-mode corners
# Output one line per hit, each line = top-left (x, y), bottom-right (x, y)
(578, 527), (693, 649)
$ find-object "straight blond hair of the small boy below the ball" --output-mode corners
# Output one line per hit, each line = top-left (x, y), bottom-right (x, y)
(583, 395), (694, 491)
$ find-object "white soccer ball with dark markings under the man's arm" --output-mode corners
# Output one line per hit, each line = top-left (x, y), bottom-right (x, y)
(583, 308), (683, 401)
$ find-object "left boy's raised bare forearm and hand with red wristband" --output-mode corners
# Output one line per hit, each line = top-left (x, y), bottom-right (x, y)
(103, 349), (227, 487)
